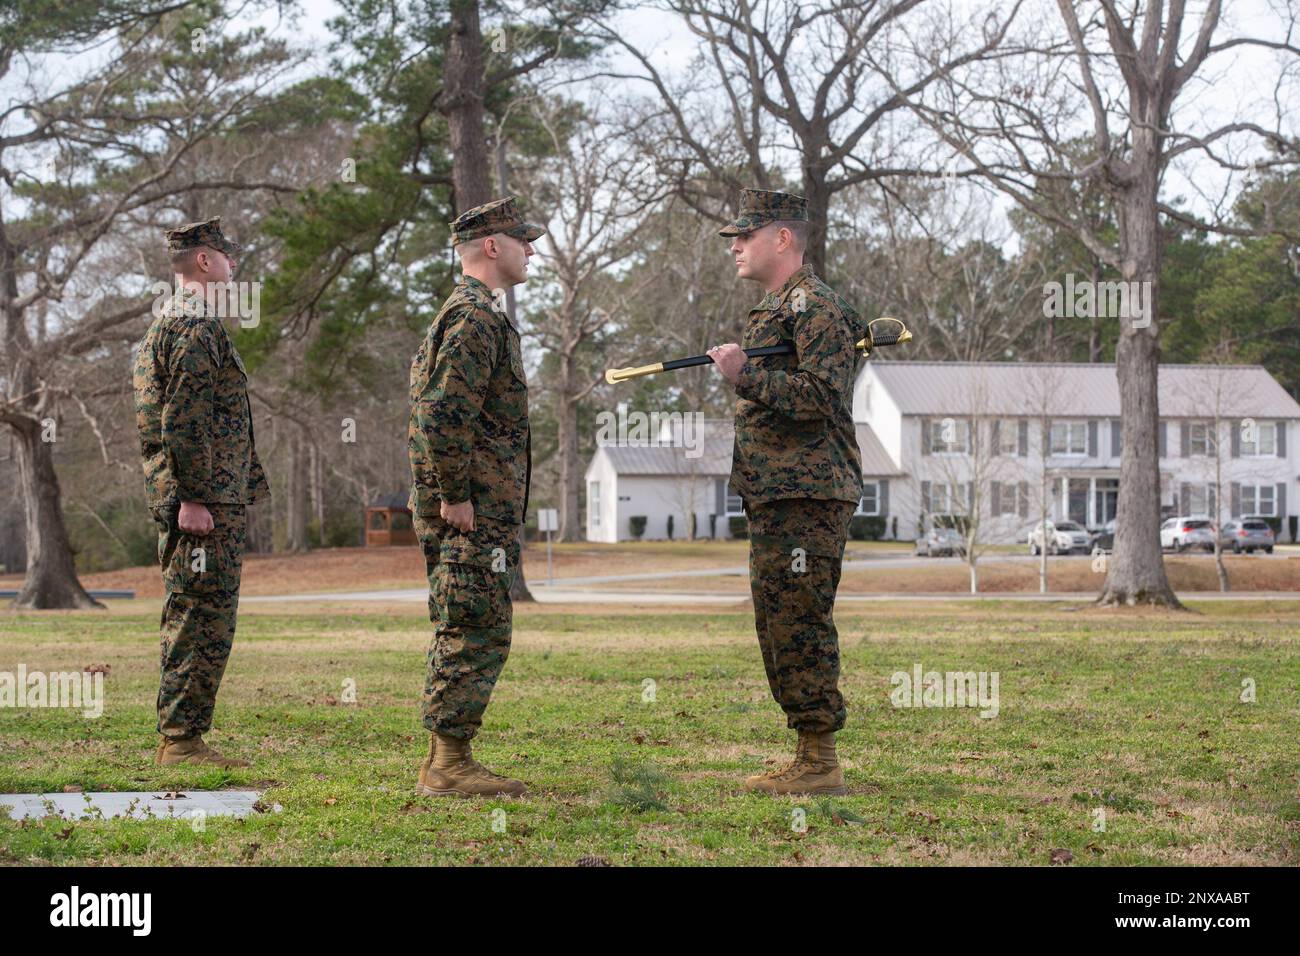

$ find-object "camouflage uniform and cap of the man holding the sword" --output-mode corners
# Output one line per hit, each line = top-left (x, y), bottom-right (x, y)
(719, 190), (866, 732)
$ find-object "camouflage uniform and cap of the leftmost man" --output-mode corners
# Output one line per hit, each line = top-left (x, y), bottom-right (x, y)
(134, 219), (269, 739)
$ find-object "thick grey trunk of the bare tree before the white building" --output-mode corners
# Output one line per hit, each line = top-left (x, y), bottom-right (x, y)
(1097, 183), (1182, 609)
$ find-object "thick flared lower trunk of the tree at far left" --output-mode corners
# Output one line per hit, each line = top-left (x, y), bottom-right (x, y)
(13, 421), (104, 610)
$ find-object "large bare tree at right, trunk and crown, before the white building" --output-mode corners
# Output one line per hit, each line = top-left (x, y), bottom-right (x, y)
(896, 0), (1300, 607)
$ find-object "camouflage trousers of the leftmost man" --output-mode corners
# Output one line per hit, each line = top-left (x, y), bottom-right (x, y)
(153, 505), (247, 737)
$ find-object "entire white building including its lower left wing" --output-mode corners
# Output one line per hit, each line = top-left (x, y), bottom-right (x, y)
(586, 362), (1300, 542)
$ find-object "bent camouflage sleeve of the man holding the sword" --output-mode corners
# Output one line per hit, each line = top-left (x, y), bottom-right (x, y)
(736, 302), (857, 421)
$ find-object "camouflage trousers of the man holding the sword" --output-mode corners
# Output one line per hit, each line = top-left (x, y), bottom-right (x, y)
(746, 498), (855, 732)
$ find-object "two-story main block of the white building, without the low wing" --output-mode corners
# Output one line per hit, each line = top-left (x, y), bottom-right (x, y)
(853, 362), (1300, 541)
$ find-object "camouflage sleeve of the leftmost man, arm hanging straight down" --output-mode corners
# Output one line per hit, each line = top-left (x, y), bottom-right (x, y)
(163, 323), (221, 502)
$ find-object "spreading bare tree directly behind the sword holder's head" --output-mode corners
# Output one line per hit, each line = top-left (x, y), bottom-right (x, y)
(593, 0), (1023, 273)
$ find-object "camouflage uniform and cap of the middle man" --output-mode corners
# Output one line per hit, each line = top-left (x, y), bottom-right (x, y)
(408, 199), (543, 740)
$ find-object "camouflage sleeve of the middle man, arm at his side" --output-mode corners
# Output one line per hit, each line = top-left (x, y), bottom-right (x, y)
(412, 306), (499, 505)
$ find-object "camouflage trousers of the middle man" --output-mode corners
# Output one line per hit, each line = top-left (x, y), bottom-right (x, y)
(413, 515), (520, 740)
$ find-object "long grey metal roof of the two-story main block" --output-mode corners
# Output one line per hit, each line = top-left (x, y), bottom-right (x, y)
(862, 362), (1300, 419)
